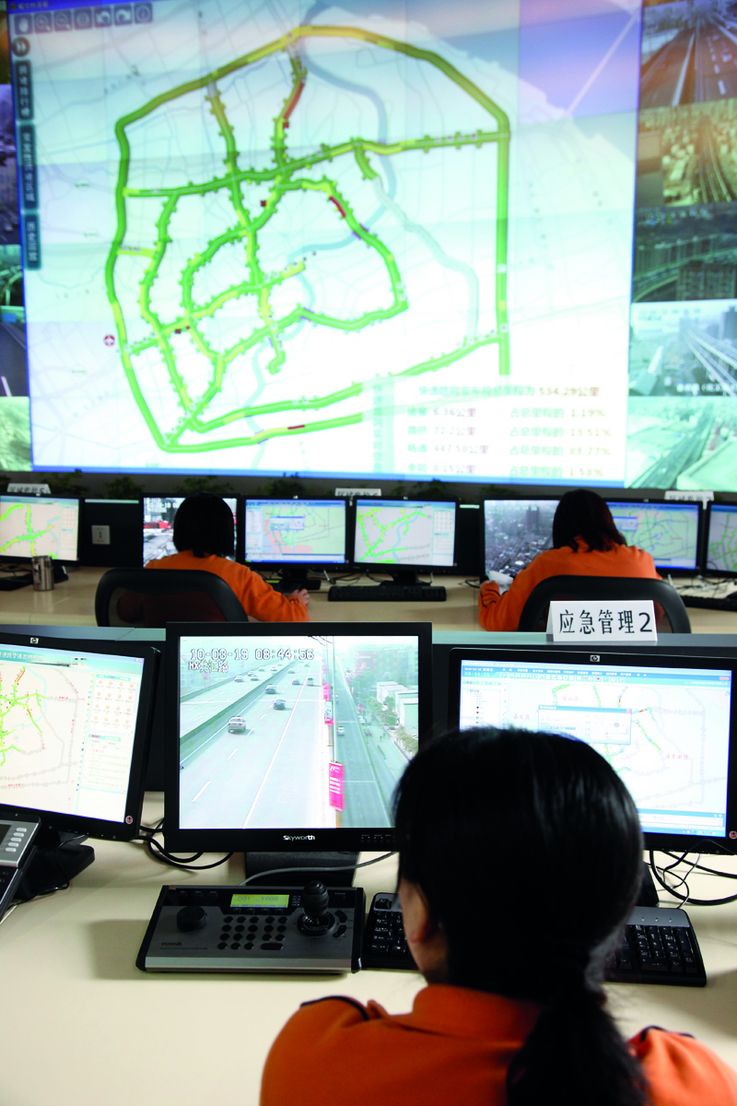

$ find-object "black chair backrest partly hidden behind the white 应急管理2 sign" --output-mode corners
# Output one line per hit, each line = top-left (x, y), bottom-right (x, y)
(518, 576), (691, 634)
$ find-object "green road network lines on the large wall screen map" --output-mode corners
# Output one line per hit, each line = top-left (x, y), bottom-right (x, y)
(105, 25), (510, 453)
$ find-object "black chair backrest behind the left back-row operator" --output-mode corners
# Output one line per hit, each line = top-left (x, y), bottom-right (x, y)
(95, 568), (248, 628)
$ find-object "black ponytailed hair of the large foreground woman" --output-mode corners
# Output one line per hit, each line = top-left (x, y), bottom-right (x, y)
(395, 729), (645, 1106)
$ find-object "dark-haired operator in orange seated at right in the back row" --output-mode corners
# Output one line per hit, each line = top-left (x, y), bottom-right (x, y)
(478, 489), (662, 630)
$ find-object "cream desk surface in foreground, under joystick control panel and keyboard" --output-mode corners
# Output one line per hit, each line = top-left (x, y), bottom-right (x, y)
(0, 800), (737, 1106)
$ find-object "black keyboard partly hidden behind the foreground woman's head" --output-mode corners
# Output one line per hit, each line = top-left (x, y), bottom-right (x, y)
(361, 891), (706, 987)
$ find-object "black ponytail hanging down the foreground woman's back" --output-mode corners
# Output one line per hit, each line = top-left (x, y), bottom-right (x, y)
(507, 988), (647, 1106)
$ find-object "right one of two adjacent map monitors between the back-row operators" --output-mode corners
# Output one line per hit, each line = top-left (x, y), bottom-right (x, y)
(353, 499), (457, 584)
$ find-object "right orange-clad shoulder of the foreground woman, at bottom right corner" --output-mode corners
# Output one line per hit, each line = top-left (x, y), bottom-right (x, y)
(630, 1026), (737, 1106)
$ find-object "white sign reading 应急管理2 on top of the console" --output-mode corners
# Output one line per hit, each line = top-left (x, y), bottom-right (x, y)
(547, 599), (657, 643)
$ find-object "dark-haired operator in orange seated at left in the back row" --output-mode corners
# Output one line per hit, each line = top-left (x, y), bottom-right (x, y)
(146, 492), (310, 622)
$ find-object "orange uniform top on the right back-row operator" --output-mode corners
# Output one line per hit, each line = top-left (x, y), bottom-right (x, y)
(478, 539), (662, 630)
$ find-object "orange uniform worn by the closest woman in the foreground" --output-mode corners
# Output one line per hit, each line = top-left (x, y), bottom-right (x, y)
(261, 983), (737, 1106)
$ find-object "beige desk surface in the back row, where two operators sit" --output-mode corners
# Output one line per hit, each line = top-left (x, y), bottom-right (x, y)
(0, 567), (737, 634)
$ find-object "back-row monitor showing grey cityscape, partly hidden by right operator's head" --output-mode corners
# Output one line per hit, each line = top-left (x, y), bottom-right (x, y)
(484, 498), (558, 576)
